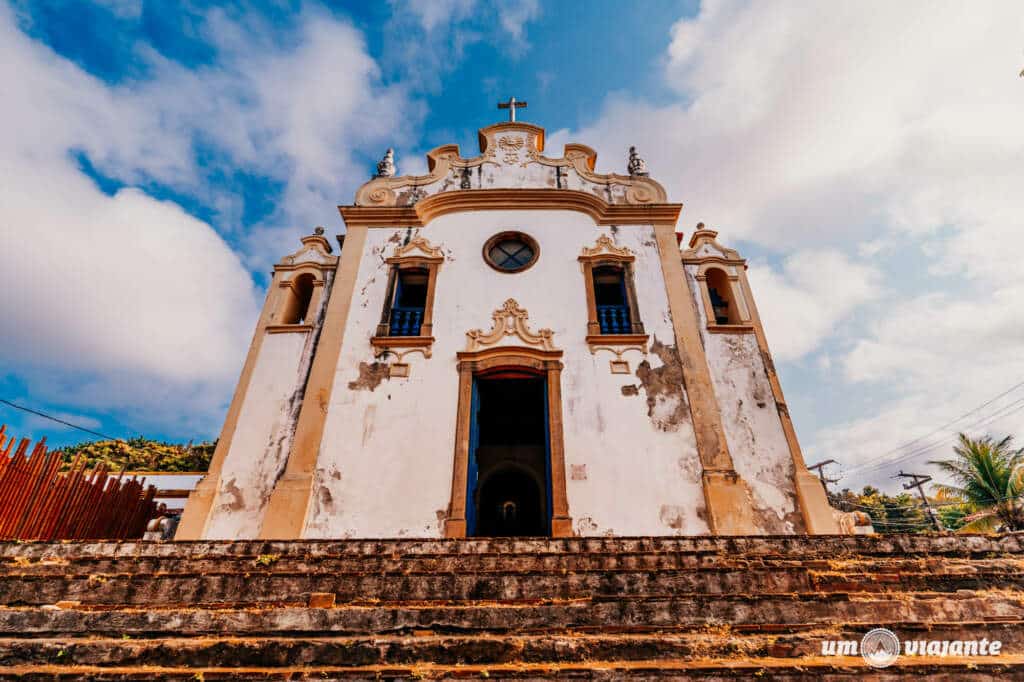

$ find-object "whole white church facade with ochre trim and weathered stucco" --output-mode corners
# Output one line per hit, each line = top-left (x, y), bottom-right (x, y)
(177, 118), (839, 540)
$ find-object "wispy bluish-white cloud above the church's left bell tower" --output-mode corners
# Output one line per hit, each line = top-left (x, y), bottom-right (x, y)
(83, 10), (420, 270)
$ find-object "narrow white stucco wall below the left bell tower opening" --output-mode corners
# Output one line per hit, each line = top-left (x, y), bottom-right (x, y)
(204, 332), (309, 540)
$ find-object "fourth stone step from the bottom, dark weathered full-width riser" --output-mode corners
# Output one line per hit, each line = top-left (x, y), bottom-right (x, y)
(0, 568), (1024, 606)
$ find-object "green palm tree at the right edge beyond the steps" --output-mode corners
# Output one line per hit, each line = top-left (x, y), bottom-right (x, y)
(929, 433), (1024, 532)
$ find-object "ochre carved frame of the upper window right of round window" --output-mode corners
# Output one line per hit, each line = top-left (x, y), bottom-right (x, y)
(579, 235), (648, 352)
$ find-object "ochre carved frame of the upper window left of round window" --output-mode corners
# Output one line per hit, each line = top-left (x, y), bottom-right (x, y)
(370, 237), (444, 350)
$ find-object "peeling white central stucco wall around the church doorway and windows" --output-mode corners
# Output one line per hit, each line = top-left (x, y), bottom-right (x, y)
(305, 211), (709, 538)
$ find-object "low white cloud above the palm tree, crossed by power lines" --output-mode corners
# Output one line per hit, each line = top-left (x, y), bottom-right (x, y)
(819, 285), (1024, 479)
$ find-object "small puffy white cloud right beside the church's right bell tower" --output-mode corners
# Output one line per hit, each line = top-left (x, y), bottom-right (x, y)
(749, 250), (882, 361)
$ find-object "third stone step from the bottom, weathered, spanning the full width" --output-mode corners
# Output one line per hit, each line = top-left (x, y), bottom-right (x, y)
(0, 592), (1024, 637)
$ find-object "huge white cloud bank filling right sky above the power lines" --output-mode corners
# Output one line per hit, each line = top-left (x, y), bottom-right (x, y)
(572, 0), (1024, 485)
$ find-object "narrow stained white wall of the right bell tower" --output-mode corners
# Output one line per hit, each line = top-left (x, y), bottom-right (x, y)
(685, 260), (805, 534)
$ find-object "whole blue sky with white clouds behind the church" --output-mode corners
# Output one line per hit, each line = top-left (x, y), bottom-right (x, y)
(0, 0), (1024, 487)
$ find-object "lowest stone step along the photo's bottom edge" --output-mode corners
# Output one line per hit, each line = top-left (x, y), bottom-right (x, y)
(0, 654), (1024, 682)
